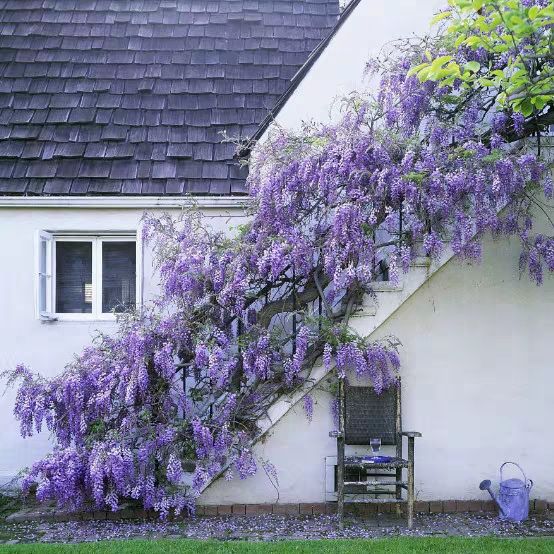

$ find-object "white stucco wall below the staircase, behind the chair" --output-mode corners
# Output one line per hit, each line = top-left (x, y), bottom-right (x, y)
(202, 223), (554, 504)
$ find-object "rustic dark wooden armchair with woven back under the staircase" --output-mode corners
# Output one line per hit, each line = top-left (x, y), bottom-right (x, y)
(329, 379), (421, 529)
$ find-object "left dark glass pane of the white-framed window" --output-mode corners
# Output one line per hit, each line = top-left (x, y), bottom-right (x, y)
(56, 242), (92, 314)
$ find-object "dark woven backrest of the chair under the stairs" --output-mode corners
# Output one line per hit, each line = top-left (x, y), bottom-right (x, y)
(344, 383), (401, 445)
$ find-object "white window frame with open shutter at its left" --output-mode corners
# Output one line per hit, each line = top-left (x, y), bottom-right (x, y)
(35, 231), (142, 322)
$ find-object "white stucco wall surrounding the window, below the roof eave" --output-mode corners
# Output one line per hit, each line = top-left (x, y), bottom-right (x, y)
(0, 204), (244, 482)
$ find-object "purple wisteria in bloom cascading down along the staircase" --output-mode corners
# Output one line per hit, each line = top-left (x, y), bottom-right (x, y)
(6, 27), (554, 517)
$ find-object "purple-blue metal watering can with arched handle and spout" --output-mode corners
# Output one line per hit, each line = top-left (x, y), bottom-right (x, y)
(479, 462), (533, 522)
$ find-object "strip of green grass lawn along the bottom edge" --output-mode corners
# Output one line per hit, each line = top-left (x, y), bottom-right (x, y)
(0, 537), (554, 554)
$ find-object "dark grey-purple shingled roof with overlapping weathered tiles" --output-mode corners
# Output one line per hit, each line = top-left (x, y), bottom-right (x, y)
(0, 0), (339, 195)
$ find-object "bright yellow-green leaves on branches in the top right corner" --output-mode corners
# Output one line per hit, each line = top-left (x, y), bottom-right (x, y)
(418, 0), (554, 117)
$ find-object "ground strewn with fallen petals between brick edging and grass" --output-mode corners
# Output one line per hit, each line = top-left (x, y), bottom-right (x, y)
(0, 513), (554, 544)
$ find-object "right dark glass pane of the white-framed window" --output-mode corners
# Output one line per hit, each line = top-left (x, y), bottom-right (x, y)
(102, 241), (136, 313)
